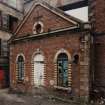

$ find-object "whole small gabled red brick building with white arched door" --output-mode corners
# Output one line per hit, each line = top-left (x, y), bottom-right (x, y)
(10, 1), (91, 98)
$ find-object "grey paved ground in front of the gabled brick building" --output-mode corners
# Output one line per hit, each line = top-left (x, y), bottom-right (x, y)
(0, 89), (105, 105)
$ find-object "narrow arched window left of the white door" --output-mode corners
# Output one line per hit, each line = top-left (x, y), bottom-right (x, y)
(17, 55), (24, 81)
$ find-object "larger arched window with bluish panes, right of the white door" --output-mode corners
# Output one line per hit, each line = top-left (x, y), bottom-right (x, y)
(57, 53), (68, 87)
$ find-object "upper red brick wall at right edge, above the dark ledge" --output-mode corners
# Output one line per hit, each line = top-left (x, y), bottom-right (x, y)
(89, 0), (105, 33)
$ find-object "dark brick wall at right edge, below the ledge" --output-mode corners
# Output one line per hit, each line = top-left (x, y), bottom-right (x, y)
(94, 36), (105, 90)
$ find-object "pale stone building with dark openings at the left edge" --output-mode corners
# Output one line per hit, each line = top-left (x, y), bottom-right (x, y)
(0, 0), (23, 88)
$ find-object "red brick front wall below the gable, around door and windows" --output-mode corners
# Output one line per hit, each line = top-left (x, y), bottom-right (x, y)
(10, 32), (81, 95)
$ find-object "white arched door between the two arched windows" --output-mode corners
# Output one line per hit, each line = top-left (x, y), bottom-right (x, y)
(34, 54), (44, 86)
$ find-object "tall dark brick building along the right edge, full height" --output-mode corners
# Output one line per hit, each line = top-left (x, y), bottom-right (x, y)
(89, 0), (105, 97)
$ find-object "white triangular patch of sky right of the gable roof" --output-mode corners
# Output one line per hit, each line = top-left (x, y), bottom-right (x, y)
(66, 7), (88, 22)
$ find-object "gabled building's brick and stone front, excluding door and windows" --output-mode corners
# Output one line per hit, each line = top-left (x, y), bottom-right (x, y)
(10, 1), (90, 98)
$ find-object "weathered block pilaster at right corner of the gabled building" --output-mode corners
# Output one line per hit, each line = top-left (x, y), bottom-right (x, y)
(80, 34), (90, 100)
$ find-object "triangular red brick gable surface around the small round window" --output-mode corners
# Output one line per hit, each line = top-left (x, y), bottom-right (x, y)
(17, 5), (73, 37)
